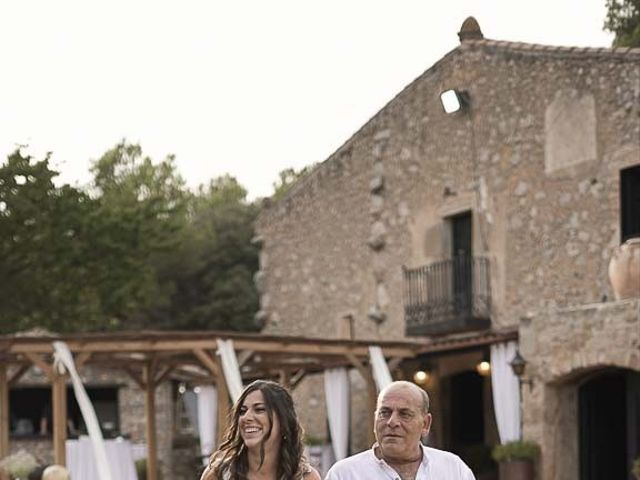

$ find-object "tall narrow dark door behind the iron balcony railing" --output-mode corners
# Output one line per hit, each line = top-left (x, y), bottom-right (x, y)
(449, 212), (473, 312)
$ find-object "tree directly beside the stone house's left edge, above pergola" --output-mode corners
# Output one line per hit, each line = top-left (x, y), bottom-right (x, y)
(155, 175), (258, 330)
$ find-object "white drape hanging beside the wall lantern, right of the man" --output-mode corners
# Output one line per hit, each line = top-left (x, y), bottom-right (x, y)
(491, 342), (521, 443)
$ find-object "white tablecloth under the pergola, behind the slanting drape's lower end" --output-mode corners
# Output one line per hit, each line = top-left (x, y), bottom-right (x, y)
(66, 436), (138, 480)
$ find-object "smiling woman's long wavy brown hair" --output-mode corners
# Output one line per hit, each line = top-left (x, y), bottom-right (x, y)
(205, 380), (303, 480)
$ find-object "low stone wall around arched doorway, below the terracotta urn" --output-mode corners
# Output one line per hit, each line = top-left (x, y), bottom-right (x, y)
(520, 299), (640, 480)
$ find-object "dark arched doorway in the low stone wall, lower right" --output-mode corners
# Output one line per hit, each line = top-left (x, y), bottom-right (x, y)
(577, 368), (640, 480)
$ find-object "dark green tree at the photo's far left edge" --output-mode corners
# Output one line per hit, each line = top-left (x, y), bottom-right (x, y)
(0, 150), (103, 332)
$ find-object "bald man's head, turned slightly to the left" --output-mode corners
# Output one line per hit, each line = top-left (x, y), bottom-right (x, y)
(375, 386), (431, 461)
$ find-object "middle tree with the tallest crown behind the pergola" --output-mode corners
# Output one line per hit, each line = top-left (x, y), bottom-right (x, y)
(86, 141), (187, 328)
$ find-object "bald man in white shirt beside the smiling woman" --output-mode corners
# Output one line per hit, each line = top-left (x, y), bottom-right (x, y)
(325, 381), (475, 480)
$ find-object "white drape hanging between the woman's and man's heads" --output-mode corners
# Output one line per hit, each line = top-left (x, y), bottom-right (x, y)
(324, 368), (349, 461)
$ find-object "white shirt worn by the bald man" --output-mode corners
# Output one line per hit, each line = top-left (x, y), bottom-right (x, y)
(325, 445), (475, 480)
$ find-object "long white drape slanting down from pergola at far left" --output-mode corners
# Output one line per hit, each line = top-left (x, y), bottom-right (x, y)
(53, 341), (113, 480)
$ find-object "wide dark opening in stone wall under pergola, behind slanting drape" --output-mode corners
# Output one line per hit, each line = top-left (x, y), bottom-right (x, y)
(9, 387), (120, 438)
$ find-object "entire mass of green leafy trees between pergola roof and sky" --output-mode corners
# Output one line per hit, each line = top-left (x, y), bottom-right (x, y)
(0, 141), (258, 332)
